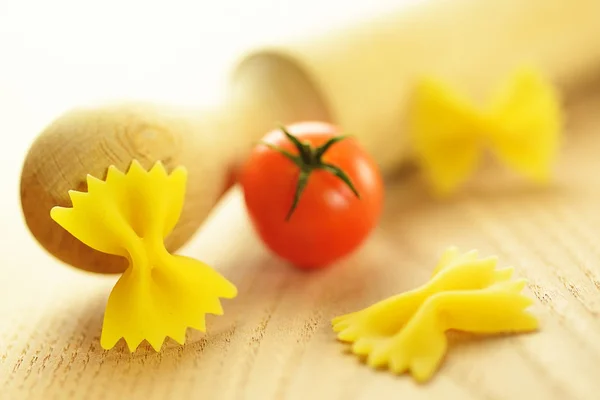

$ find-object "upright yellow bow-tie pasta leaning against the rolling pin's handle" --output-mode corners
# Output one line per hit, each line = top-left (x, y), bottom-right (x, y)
(51, 160), (237, 352)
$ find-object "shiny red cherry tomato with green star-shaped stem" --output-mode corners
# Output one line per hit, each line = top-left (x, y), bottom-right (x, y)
(239, 122), (384, 269)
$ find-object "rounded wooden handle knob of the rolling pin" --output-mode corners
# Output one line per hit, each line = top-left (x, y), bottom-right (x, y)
(20, 103), (231, 273)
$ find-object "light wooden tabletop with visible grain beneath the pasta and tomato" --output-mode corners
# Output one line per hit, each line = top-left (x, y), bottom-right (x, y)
(0, 81), (600, 400)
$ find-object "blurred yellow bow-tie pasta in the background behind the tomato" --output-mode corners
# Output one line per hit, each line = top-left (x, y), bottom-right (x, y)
(409, 68), (563, 195)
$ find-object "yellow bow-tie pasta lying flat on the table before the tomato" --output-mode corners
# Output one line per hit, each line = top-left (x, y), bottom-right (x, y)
(333, 248), (538, 382)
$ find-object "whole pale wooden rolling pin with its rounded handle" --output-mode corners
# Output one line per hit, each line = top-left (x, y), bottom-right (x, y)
(20, 0), (600, 273)
